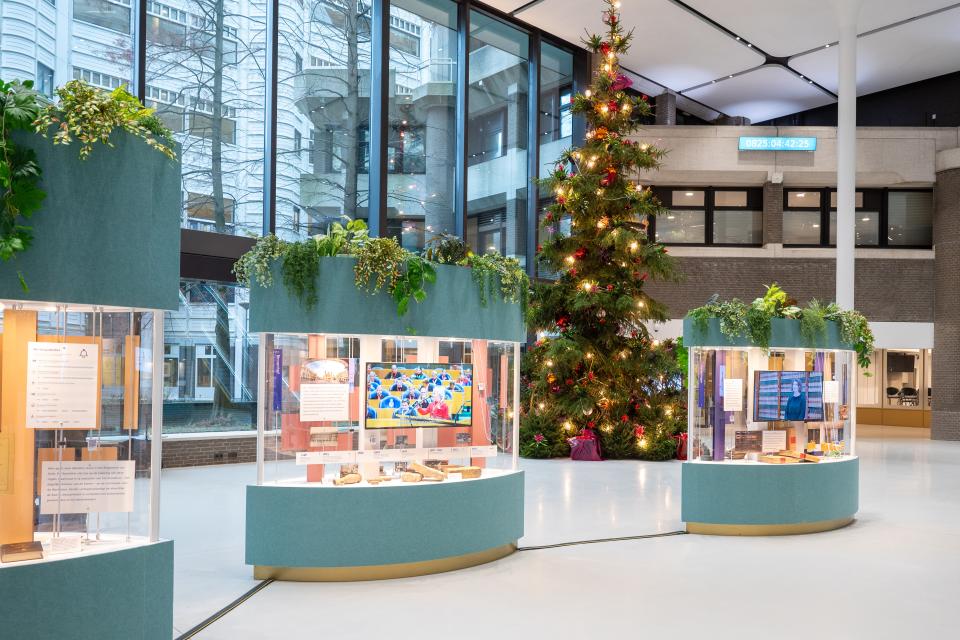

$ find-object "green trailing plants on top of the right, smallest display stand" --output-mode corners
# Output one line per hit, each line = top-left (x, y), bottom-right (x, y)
(687, 283), (873, 368)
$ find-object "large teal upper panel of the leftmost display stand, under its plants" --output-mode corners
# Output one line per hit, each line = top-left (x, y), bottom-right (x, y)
(0, 132), (180, 311)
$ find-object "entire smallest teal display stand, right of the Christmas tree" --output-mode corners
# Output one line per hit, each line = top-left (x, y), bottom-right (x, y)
(681, 318), (859, 535)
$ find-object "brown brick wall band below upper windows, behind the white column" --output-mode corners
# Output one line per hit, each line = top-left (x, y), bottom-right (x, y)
(646, 255), (932, 322)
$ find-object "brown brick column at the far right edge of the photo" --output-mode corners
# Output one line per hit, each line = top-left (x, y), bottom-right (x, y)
(930, 149), (960, 440)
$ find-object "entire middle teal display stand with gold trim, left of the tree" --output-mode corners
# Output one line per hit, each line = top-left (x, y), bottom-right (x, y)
(246, 257), (526, 581)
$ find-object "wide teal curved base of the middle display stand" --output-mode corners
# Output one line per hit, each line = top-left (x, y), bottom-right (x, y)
(246, 471), (523, 568)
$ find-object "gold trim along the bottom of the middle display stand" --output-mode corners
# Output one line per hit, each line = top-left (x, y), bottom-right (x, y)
(253, 543), (517, 582)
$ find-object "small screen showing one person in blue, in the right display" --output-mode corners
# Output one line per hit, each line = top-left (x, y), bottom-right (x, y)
(753, 371), (823, 422)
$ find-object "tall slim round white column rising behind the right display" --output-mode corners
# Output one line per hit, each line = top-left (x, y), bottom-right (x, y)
(836, 0), (862, 309)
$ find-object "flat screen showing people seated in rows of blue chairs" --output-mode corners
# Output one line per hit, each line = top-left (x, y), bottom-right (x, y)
(364, 362), (473, 429)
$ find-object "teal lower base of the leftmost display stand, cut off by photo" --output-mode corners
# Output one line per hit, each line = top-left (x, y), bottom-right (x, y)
(0, 540), (173, 640)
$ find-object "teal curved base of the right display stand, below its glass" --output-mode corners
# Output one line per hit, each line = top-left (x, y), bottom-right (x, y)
(680, 458), (860, 524)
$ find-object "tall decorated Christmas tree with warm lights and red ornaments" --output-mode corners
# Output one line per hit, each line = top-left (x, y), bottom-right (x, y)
(521, 0), (686, 460)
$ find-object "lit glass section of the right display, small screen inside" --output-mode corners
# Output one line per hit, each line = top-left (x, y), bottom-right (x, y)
(688, 347), (857, 464)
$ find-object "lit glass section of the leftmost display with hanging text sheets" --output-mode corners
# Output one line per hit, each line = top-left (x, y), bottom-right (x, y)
(0, 301), (163, 560)
